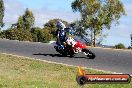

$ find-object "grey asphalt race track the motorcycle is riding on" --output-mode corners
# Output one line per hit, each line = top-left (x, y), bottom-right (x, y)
(0, 39), (132, 74)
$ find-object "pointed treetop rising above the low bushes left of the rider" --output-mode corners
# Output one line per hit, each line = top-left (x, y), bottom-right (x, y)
(22, 8), (35, 30)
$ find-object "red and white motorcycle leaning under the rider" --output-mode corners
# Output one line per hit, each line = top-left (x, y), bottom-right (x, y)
(53, 37), (95, 59)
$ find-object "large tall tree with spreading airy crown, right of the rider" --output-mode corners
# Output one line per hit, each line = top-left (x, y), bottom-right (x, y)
(71, 0), (125, 46)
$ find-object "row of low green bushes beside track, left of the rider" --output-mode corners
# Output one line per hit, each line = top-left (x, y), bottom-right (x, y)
(0, 27), (53, 43)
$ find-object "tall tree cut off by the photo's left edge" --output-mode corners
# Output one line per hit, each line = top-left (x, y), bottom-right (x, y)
(0, 0), (5, 27)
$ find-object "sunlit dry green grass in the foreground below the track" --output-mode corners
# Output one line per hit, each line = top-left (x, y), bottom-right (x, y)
(0, 54), (132, 88)
